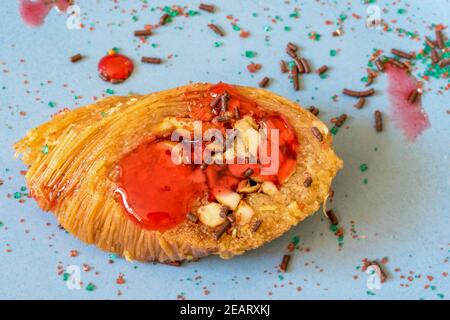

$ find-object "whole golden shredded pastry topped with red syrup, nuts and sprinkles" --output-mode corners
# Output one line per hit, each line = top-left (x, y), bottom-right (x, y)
(15, 83), (342, 262)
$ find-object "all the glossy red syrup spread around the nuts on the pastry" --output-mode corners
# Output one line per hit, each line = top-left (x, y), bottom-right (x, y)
(116, 83), (298, 231)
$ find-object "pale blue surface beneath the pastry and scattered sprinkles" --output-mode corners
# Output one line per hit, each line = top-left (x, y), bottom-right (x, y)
(0, 0), (450, 299)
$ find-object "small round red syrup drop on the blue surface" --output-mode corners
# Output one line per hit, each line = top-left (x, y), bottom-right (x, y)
(98, 54), (134, 84)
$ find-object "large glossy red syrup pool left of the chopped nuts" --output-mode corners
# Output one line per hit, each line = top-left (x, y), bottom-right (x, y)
(117, 141), (207, 231)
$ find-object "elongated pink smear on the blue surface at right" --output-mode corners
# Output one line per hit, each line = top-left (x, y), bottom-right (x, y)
(386, 64), (430, 142)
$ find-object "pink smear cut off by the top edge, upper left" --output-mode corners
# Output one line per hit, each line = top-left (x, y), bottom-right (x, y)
(19, 0), (71, 27)
